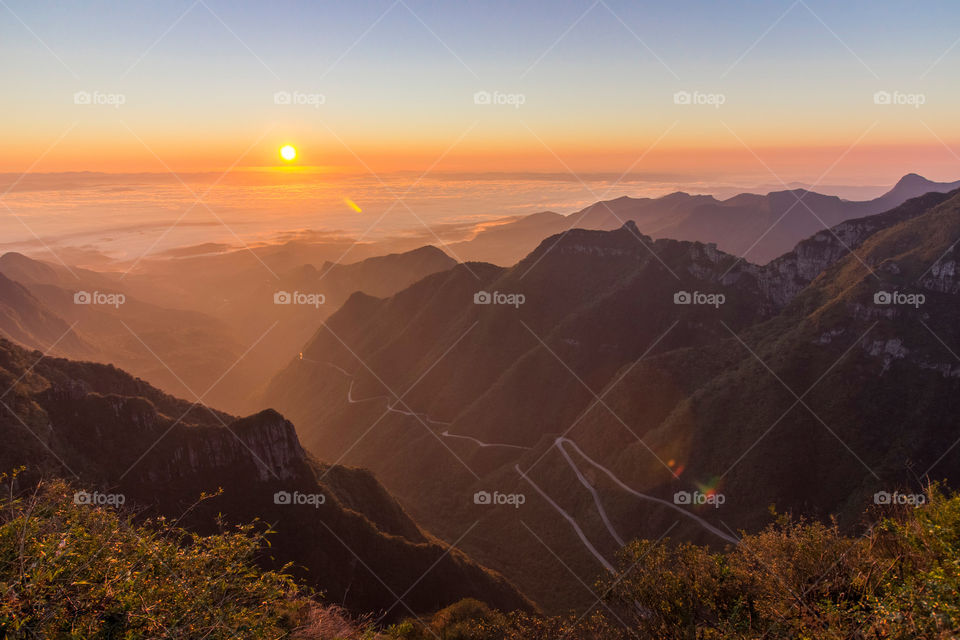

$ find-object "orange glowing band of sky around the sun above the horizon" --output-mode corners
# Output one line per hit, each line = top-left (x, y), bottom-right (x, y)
(0, 132), (960, 184)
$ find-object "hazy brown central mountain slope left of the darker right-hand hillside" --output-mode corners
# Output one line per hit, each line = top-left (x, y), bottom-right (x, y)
(263, 223), (781, 606)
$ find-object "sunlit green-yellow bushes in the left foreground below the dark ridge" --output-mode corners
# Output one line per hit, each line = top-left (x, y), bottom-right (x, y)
(0, 481), (374, 640)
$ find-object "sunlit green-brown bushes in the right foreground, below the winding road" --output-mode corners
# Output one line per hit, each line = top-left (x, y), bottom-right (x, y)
(390, 488), (960, 640)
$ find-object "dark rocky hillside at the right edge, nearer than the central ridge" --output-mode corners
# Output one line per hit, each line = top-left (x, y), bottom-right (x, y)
(574, 190), (960, 540)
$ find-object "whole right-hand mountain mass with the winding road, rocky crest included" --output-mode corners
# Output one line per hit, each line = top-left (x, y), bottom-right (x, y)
(266, 186), (960, 610)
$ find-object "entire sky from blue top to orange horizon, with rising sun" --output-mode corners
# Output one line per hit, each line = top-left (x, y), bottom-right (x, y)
(0, 0), (960, 184)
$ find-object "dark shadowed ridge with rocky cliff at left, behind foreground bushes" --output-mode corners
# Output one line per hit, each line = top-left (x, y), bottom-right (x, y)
(0, 340), (531, 617)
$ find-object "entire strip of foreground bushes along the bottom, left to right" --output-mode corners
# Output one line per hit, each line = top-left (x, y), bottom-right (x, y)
(0, 472), (960, 640)
